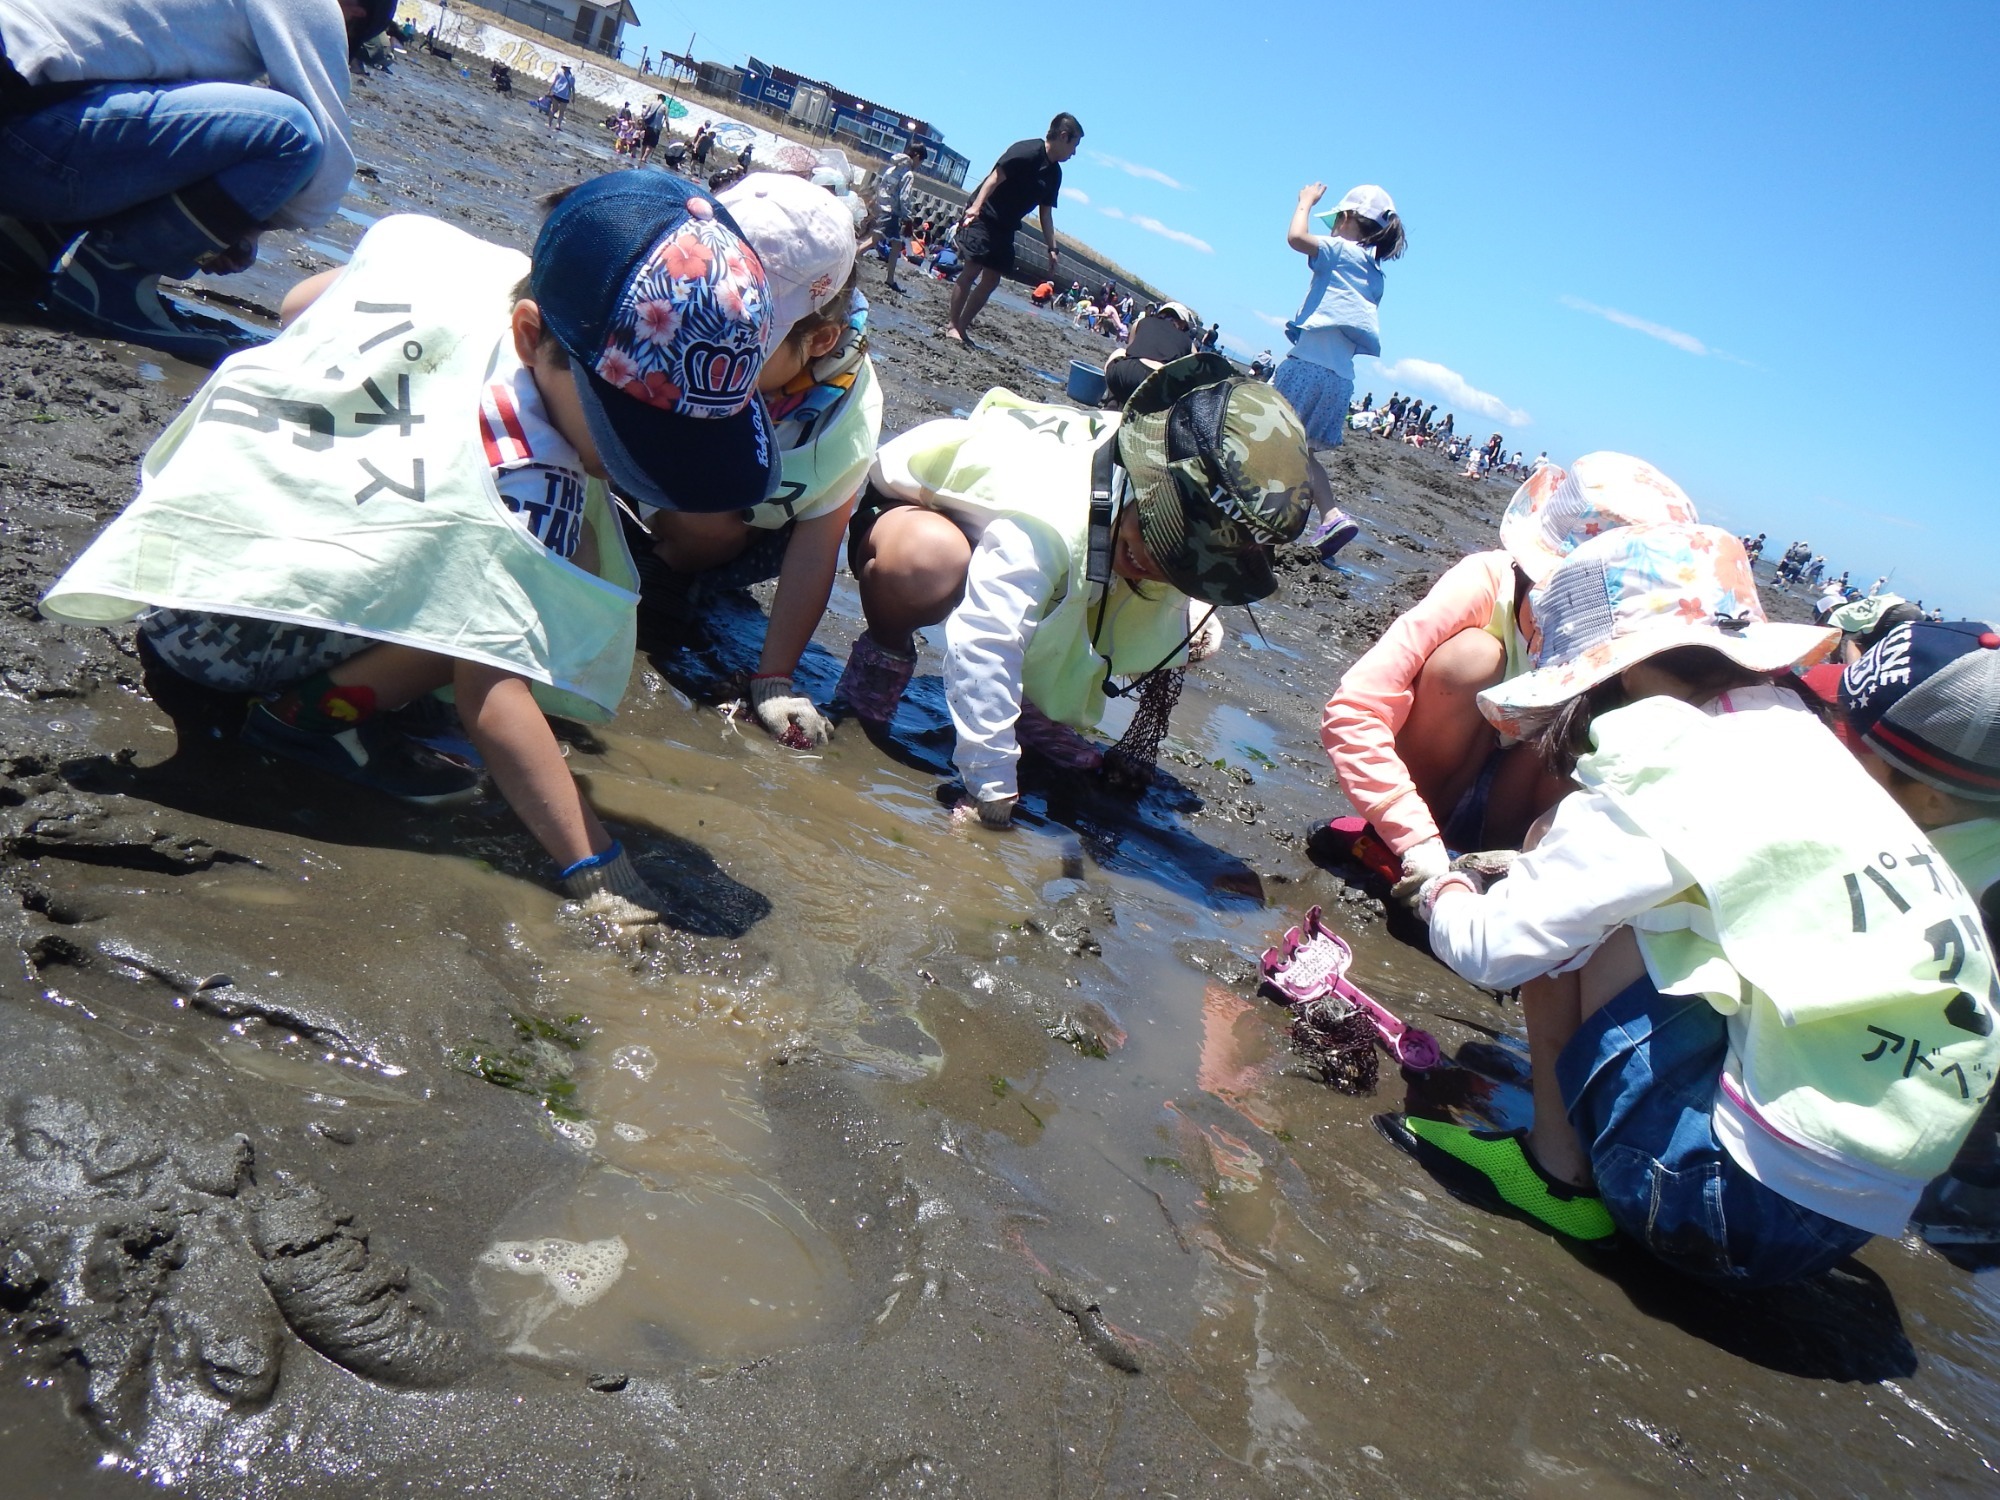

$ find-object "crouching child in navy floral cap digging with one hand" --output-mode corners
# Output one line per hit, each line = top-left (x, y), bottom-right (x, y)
(42, 172), (774, 922)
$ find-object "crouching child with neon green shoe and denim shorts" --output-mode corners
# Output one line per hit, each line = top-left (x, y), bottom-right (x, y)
(1384, 526), (2000, 1288)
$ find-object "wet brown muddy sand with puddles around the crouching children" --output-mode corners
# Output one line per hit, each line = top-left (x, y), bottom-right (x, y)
(0, 47), (2000, 1500)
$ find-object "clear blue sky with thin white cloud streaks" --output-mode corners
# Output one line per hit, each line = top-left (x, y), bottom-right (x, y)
(634, 0), (2000, 620)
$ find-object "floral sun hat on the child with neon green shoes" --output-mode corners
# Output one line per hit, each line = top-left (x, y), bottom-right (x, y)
(1480, 524), (1840, 736)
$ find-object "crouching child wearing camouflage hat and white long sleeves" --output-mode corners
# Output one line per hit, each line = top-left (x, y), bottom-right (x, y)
(840, 354), (1312, 828)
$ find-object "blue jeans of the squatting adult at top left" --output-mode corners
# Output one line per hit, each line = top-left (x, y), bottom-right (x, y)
(0, 84), (324, 276)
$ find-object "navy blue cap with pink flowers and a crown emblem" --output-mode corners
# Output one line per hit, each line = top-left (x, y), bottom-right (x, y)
(530, 172), (778, 512)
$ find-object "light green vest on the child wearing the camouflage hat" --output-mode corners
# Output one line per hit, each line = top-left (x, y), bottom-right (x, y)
(876, 390), (1188, 728)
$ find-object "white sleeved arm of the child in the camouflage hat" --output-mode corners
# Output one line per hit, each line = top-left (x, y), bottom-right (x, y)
(944, 516), (1066, 802)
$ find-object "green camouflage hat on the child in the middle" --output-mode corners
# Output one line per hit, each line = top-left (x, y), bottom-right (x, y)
(1118, 354), (1312, 604)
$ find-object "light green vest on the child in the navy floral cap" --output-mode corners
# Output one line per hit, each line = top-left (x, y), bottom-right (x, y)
(42, 214), (636, 720)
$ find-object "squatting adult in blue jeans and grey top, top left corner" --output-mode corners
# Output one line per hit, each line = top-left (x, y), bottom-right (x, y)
(0, 0), (394, 364)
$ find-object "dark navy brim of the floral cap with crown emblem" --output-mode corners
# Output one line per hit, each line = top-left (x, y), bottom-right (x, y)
(570, 356), (778, 514)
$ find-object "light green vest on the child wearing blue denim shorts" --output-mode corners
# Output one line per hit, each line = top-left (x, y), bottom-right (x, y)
(1576, 698), (2000, 1178)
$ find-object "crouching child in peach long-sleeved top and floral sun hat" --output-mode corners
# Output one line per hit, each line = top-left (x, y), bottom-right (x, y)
(1320, 452), (1698, 902)
